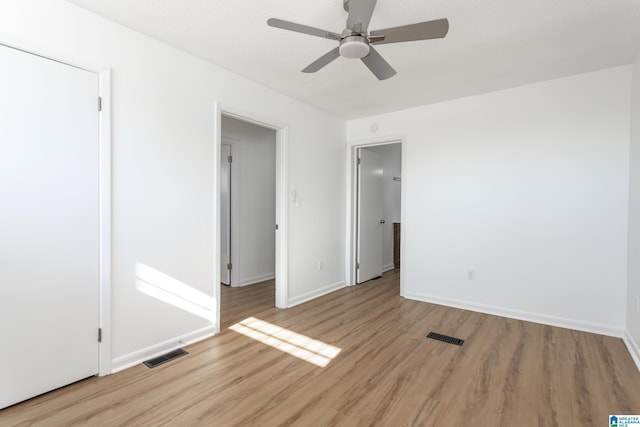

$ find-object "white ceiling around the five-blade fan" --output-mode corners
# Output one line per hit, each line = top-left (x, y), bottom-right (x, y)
(68, 0), (640, 119)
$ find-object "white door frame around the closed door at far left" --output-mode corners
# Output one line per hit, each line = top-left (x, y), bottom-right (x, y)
(0, 39), (112, 376)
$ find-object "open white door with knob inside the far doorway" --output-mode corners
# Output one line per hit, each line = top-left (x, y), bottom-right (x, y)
(356, 148), (384, 283)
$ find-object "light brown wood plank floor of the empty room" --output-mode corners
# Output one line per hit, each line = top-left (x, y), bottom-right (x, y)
(0, 270), (640, 427)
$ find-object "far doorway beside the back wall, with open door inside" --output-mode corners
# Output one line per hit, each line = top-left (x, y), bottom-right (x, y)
(347, 140), (404, 289)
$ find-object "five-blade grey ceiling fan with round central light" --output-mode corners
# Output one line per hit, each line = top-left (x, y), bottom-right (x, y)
(267, 0), (449, 80)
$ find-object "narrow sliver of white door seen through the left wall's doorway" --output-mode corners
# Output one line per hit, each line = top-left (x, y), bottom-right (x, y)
(220, 144), (232, 285)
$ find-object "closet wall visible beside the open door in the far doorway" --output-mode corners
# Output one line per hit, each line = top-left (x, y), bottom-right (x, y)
(368, 144), (402, 271)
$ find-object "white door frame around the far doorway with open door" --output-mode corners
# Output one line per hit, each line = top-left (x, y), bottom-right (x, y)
(345, 134), (407, 296)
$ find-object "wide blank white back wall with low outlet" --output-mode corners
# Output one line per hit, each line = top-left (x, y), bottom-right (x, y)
(347, 66), (631, 336)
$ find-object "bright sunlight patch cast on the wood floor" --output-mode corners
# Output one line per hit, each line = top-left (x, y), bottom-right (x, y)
(229, 317), (341, 368)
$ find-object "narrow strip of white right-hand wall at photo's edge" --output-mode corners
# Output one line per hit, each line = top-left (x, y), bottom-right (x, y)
(626, 55), (640, 368)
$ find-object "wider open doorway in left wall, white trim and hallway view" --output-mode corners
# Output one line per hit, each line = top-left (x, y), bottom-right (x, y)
(214, 103), (288, 330)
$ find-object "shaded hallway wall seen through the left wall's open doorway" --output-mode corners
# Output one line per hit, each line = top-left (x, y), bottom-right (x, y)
(222, 116), (276, 286)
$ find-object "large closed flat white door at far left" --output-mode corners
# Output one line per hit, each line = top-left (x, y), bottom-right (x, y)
(0, 45), (99, 408)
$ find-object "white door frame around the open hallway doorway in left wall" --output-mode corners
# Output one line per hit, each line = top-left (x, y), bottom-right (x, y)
(213, 101), (289, 332)
